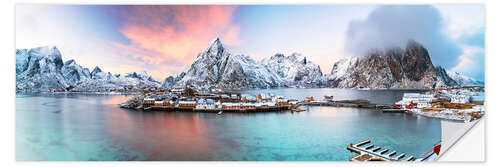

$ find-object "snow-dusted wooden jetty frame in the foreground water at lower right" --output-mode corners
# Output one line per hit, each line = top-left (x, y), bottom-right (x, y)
(347, 139), (415, 161)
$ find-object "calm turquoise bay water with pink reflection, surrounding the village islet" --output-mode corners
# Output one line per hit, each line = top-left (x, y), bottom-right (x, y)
(16, 89), (441, 161)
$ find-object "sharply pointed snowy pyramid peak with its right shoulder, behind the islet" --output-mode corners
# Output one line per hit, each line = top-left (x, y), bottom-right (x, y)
(177, 38), (281, 89)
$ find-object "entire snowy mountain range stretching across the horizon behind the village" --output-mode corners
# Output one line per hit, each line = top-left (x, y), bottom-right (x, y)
(16, 38), (483, 92)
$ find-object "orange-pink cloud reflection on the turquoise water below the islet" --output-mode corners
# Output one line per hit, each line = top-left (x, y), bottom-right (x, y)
(107, 109), (215, 160)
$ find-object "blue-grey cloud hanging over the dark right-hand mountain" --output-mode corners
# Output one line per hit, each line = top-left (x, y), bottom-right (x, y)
(345, 5), (462, 68)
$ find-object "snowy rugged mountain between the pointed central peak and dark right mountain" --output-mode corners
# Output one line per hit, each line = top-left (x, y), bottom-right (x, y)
(262, 53), (323, 87)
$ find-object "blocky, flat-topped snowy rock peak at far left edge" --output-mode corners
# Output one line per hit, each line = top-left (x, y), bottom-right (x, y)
(16, 47), (69, 91)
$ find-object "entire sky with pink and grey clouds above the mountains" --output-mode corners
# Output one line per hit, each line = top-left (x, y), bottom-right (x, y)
(15, 4), (485, 81)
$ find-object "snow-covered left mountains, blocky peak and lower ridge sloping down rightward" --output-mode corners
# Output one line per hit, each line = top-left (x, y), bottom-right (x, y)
(16, 46), (161, 92)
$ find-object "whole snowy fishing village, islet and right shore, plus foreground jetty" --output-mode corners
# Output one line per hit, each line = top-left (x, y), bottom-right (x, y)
(120, 87), (485, 161)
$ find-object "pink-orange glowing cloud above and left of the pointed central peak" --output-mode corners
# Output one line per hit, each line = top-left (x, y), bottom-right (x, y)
(112, 5), (240, 79)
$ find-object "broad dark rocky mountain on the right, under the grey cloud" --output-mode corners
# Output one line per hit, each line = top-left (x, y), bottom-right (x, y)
(326, 40), (456, 89)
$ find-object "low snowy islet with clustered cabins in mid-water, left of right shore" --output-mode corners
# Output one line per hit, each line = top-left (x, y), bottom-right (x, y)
(120, 87), (394, 113)
